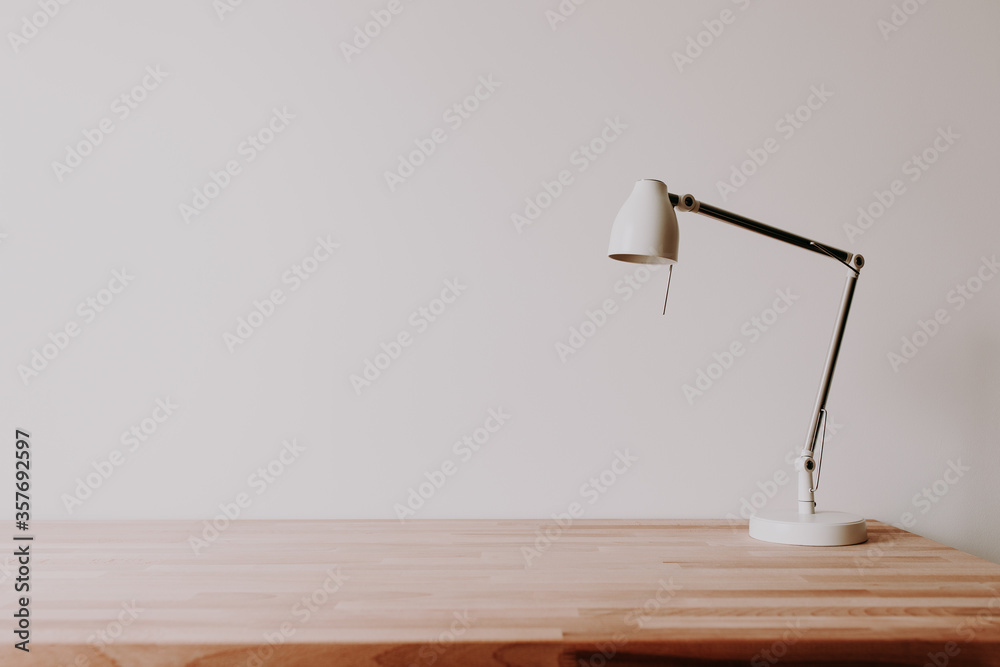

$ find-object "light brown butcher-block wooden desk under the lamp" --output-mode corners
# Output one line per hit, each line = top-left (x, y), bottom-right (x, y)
(13, 520), (1000, 667)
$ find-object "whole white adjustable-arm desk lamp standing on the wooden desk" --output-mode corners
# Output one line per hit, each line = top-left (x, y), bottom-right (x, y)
(608, 179), (868, 546)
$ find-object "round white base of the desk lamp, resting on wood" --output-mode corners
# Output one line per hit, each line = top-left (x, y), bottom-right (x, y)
(750, 510), (868, 547)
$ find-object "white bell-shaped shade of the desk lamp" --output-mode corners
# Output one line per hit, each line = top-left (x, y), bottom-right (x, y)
(608, 179), (678, 264)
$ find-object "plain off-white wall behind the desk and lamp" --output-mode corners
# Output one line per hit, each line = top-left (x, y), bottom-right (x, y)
(0, 0), (1000, 561)
